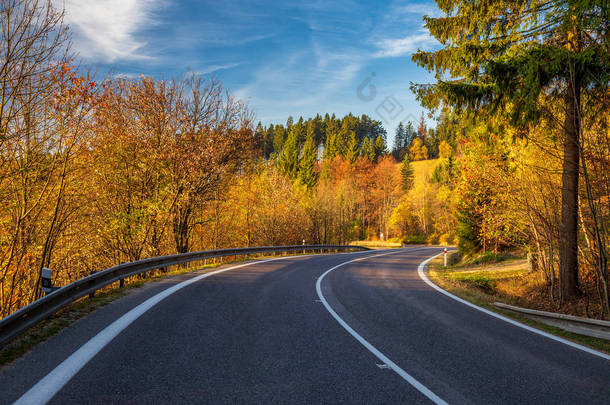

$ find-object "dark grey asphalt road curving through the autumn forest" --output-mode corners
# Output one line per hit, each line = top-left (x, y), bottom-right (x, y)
(0, 248), (610, 404)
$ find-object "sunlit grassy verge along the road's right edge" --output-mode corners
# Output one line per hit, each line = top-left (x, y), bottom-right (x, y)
(428, 258), (610, 354)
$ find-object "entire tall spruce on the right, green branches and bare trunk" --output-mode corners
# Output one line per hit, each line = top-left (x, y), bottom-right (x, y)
(412, 0), (610, 299)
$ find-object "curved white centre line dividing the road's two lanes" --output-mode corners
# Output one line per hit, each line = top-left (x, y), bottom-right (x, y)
(316, 251), (447, 405)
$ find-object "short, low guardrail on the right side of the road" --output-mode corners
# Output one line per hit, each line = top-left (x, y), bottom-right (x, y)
(494, 302), (610, 340)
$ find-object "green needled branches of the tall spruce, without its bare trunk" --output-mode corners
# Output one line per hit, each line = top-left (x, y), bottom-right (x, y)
(412, 0), (610, 123)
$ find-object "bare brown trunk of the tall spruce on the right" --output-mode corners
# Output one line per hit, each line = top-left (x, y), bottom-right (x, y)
(559, 78), (580, 300)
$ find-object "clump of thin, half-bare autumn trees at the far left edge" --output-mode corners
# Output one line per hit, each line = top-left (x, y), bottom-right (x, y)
(0, 0), (73, 316)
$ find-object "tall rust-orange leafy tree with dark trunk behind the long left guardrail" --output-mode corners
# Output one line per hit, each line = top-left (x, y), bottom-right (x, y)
(171, 75), (253, 253)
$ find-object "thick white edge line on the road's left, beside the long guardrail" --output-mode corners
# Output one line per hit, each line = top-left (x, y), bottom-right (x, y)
(15, 251), (367, 405)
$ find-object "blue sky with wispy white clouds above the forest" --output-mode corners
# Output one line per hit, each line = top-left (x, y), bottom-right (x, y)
(56, 0), (438, 136)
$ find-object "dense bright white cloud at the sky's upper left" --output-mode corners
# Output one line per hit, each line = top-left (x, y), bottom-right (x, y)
(54, 0), (165, 62)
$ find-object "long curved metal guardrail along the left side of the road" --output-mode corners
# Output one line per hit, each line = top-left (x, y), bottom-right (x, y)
(0, 245), (369, 345)
